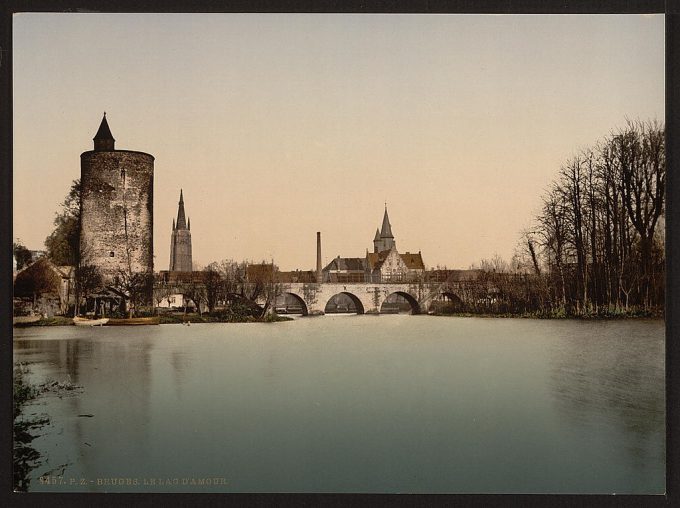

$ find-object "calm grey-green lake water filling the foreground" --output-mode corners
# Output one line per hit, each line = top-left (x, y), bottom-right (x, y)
(14, 315), (665, 493)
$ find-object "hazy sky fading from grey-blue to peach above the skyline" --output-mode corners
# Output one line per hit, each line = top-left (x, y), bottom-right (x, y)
(13, 13), (665, 270)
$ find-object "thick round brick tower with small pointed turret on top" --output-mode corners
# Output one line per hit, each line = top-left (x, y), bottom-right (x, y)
(80, 113), (154, 284)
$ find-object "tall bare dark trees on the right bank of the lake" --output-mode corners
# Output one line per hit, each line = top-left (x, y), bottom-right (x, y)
(468, 121), (666, 316)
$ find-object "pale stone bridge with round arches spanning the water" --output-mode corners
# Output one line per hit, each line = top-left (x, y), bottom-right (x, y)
(274, 282), (470, 314)
